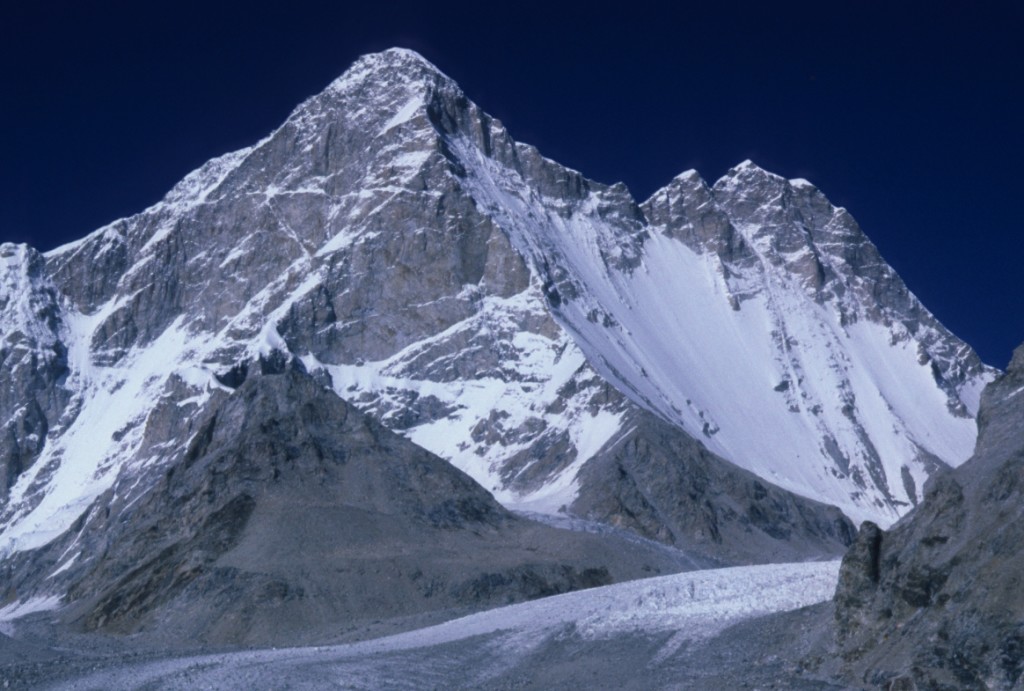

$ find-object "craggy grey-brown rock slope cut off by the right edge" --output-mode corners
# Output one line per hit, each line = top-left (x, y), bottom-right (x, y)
(836, 348), (1024, 689)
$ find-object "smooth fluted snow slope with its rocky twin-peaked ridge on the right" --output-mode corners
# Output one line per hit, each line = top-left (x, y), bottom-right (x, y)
(454, 140), (993, 524)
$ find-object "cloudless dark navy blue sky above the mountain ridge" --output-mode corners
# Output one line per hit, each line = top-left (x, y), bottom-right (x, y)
(0, 0), (1024, 366)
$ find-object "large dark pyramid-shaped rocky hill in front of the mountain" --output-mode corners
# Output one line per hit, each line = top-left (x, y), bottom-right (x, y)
(51, 368), (692, 645)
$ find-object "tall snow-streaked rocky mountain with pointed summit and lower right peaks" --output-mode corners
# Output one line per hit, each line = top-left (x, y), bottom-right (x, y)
(0, 50), (992, 563)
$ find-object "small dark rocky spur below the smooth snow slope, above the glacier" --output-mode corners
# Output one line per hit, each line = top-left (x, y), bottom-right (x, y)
(571, 412), (854, 564)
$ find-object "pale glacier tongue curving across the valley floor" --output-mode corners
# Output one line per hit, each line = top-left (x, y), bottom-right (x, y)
(32, 561), (839, 689)
